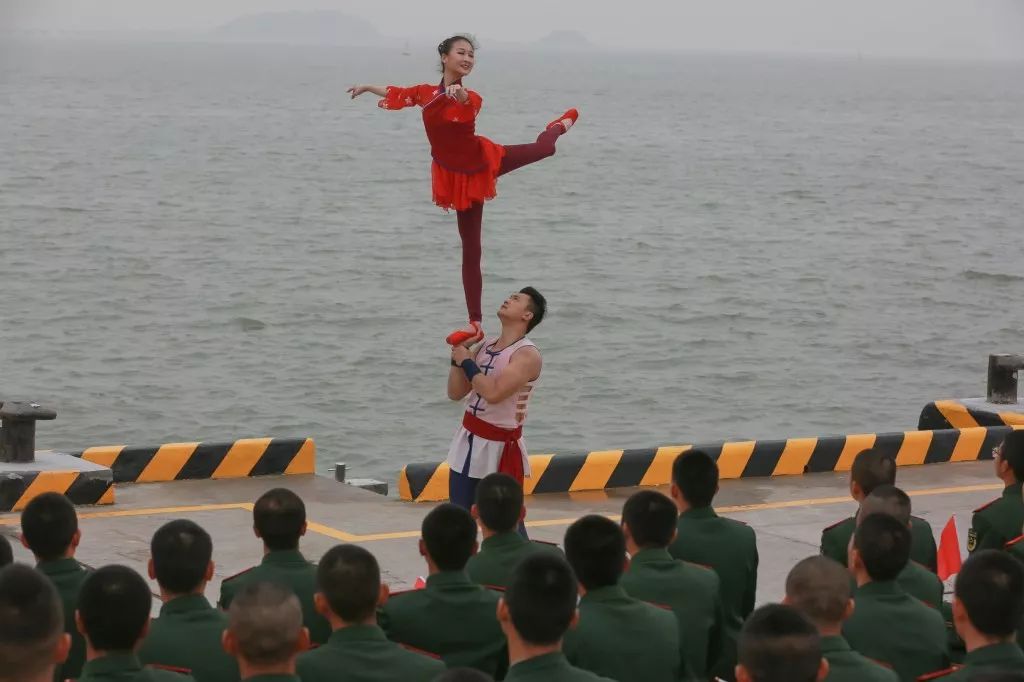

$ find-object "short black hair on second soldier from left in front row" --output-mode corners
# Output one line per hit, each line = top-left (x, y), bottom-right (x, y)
(78, 564), (153, 651)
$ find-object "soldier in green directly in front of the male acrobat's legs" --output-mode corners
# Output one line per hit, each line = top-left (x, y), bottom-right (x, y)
(466, 473), (561, 588)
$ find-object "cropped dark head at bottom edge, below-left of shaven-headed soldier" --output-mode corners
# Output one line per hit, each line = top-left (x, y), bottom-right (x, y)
(738, 604), (821, 682)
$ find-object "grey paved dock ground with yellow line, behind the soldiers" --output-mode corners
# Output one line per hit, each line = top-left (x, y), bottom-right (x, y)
(0, 462), (1002, 602)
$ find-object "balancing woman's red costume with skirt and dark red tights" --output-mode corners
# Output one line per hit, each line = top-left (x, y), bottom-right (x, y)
(377, 82), (577, 323)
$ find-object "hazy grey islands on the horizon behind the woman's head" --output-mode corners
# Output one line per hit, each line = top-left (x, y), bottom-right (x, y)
(207, 10), (598, 51)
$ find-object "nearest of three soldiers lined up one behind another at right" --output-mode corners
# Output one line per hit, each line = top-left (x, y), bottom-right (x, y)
(843, 513), (949, 682)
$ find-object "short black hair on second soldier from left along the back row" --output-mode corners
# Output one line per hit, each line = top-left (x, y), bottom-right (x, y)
(150, 519), (213, 594)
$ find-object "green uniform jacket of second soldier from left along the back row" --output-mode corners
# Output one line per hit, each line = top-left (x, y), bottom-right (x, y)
(138, 594), (239, 682)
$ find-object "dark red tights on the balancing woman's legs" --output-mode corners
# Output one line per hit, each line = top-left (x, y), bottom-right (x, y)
(456, 126), (564, 322)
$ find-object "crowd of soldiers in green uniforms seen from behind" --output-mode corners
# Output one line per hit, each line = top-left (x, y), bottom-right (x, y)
(0, 431), (1024, 682)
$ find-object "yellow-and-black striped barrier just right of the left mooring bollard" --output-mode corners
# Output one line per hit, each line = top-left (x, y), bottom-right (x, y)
(76, 438), (316, 483)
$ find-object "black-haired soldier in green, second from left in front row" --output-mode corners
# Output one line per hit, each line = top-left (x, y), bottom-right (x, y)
(76, 565), (195, 682)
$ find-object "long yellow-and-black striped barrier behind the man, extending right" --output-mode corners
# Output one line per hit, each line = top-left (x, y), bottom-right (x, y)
(398, 425), (1024, 502)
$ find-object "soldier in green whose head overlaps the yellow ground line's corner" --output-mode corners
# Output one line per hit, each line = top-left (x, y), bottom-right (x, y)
(218, 487), (331, 644)
